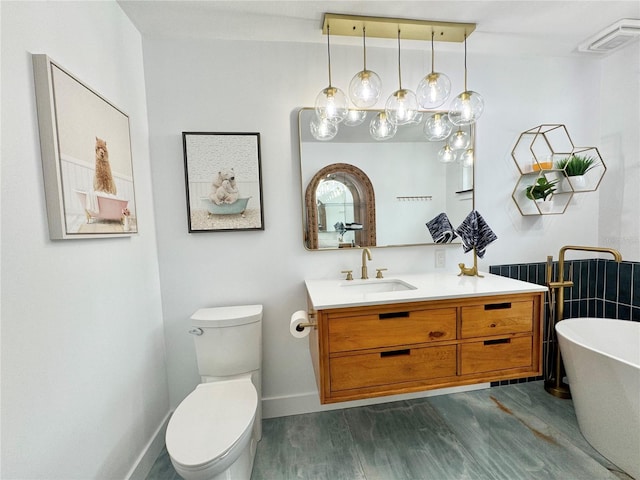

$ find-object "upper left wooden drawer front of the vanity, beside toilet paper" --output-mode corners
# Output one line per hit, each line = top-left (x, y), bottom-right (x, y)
(329, 308), (456, 352)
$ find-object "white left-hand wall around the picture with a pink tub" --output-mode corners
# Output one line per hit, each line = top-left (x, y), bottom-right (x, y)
(0, 2), (169, 480)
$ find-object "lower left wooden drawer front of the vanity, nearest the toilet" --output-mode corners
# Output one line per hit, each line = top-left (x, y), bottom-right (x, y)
(329, 345), (456, 391)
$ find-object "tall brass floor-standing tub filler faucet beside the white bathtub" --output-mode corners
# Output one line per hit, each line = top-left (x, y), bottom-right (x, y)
(544, 245), (622, 398)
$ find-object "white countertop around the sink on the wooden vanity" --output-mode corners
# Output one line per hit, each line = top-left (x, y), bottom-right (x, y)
(305, 272), (547, 310)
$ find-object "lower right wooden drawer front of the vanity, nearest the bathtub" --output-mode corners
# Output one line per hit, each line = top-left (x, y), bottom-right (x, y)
(460, 337), (533, 375)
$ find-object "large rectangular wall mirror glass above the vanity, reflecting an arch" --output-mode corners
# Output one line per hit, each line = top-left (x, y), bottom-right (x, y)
(298, 108), (475, 250)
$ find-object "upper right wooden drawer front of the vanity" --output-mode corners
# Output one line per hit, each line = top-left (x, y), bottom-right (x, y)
(461, 300), (533, 338)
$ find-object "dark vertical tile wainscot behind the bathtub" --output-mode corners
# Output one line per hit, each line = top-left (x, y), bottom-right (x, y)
(489, 258), (640, 385)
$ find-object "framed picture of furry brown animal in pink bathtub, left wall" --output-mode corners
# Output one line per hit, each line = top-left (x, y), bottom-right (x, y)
(32, 54), (138, 240)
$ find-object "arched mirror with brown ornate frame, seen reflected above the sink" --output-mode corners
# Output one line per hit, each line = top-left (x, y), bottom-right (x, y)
(305, 163), (376, 250)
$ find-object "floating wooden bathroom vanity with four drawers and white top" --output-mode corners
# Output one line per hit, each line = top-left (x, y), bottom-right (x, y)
(305, 274), (546, 404)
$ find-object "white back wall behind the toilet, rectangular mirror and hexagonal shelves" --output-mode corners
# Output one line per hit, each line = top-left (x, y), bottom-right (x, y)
(144, 34), (632, 415)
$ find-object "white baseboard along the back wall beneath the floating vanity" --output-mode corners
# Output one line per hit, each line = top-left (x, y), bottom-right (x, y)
(262, 383), (491, 418)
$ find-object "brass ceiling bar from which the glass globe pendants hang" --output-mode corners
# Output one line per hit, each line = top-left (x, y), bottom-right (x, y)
(322, 13), (476, 42)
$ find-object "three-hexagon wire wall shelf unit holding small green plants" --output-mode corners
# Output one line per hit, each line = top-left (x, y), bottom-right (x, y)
(511, 124), (607, 215)
